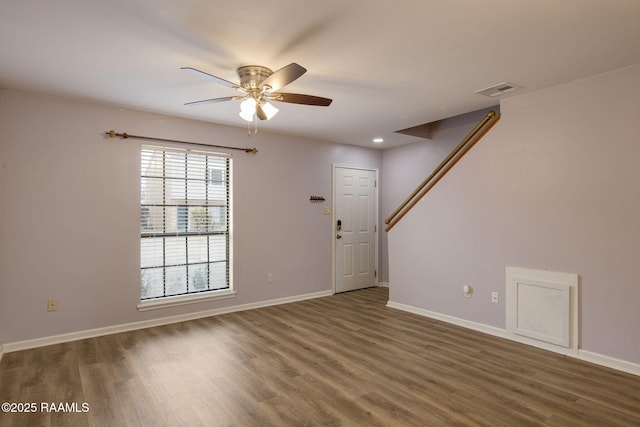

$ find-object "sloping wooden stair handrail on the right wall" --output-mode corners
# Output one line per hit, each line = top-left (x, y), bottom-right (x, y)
(384, 110), (500, 231)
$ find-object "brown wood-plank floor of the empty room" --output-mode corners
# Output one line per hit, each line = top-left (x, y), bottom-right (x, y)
(0, 288), (640, 427)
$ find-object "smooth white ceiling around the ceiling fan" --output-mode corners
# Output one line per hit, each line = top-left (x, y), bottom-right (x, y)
(0, 0), (640, 148)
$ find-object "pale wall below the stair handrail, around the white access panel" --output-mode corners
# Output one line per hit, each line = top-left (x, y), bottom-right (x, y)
(384, 66), (640, 364)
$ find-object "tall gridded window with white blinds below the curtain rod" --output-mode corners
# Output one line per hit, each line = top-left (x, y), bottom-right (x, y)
(139, 146), (232, 307)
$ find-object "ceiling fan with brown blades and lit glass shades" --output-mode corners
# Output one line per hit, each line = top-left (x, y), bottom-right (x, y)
(181, 62), (332, 122)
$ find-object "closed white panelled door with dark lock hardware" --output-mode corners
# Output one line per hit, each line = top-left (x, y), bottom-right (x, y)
(333, 167), (377, 292)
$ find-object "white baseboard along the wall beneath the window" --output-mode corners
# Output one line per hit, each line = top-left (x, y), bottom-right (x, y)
(0, 290), (333, 360)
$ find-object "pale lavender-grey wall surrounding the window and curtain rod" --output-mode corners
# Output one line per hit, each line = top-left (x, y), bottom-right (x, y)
(0, 90), (382, 344)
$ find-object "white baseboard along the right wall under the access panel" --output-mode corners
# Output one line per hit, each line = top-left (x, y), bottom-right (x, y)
(387, 301), (640, 376)
